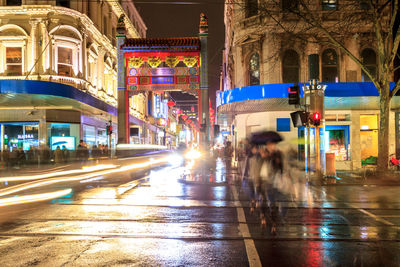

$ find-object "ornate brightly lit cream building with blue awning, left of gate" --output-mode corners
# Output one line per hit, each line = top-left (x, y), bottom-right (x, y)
(0, 0), (148, 150)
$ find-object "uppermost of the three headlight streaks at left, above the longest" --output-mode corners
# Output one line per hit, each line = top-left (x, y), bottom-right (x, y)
(0, 164), (117, 182)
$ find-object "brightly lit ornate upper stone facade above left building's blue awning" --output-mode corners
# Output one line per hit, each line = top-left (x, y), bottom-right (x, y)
(0, 0), (146, 119)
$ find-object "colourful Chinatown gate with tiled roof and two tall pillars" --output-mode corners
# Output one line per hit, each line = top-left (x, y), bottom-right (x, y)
(117, 13), (210, 146)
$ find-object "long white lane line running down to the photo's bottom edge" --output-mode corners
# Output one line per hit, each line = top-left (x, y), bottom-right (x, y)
(231, 186), (262, 267)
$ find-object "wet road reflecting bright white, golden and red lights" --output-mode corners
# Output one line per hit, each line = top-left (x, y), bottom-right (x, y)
(0, 160), (400, 266)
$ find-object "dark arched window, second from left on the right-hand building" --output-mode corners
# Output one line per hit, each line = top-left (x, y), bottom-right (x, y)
(282, 50), (300, 83)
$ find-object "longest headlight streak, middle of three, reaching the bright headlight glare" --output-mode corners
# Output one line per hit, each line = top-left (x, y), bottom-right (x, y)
(0, 157), (168, 201)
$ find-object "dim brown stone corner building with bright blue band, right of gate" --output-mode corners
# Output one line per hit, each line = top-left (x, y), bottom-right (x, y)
(217, 0), (400, 170)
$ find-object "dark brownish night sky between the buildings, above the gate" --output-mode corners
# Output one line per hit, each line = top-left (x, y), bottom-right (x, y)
(134, 0), (224, 107)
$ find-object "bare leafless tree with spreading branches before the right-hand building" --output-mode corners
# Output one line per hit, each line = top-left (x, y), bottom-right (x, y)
(234, 0), (400, 170)
